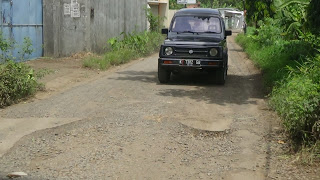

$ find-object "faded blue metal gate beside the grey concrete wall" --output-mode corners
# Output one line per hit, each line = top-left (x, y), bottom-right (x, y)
(0, 0), (43, 61)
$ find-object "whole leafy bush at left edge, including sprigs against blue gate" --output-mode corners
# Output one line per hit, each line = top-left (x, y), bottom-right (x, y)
(0, 31), (41, 108)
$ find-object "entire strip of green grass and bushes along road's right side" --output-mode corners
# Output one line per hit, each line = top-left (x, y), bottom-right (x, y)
(236, 20), (320, 163)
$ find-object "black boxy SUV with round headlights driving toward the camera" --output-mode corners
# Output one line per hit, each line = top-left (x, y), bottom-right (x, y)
(158, 8), (232, 84)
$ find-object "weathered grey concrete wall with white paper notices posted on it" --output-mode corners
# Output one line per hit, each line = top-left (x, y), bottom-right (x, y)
(43, 0), (147, 57)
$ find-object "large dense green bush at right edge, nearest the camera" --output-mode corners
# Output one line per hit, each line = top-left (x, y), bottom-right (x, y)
(270, 56), (320, 144)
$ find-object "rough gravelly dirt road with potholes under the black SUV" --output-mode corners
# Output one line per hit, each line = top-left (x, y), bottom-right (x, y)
(0, 34), (317, 180)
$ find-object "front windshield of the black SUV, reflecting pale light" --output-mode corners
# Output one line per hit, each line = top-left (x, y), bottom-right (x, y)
(171, 16), (221, 33)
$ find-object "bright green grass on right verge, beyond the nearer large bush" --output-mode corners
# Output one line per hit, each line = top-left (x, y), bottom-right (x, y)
(236, 29), (310, 89)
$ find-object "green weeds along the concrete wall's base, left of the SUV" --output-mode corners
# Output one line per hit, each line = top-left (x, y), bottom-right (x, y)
(83, 31), (164, 70)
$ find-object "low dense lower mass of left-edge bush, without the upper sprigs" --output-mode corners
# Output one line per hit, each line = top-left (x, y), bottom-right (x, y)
(0, 60), (39, 108)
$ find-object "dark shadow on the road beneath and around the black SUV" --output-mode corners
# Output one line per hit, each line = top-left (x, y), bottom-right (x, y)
(114, 71), (264, 105)
